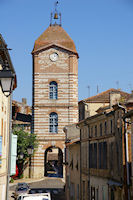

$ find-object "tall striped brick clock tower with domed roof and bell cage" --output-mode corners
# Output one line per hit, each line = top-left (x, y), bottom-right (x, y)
(31, 3), (78, 178)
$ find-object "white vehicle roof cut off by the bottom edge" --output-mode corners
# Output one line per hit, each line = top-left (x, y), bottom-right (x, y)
(17, 192), (51, 200)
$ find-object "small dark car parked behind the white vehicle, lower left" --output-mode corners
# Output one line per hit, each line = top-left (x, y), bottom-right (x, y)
(14, 183), (30, 199)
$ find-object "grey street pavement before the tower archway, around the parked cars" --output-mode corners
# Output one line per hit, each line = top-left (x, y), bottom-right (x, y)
(9, 177), (65, 200)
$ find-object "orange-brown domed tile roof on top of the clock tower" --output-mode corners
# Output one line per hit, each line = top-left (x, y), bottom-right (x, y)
(32, 25), (77, 54)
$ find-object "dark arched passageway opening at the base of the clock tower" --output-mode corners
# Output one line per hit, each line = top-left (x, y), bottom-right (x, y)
(44, 146), (63, 178)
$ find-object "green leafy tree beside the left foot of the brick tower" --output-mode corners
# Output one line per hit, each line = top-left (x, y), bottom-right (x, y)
(13, 126), (38, 176)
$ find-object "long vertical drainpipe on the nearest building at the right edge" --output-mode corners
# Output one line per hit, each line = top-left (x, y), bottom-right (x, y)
(118, 103), (130, 200)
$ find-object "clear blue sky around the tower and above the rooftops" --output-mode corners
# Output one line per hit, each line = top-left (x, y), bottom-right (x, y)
(0, 0), (133, 105)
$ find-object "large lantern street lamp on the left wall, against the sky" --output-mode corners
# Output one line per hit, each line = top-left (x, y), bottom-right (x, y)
(0, 66), (15, 97)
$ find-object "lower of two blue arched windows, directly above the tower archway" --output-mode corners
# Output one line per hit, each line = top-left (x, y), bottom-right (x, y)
(49, 112), (58, 133)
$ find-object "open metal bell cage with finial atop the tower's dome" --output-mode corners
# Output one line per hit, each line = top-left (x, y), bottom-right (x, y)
(50, 1), (61, 26)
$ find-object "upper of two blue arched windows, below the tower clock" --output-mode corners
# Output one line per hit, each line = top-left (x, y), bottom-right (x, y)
(49, 81), (58, 99)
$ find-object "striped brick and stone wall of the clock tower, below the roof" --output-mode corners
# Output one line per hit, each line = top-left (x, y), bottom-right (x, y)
(32, 47), (78, 177)
